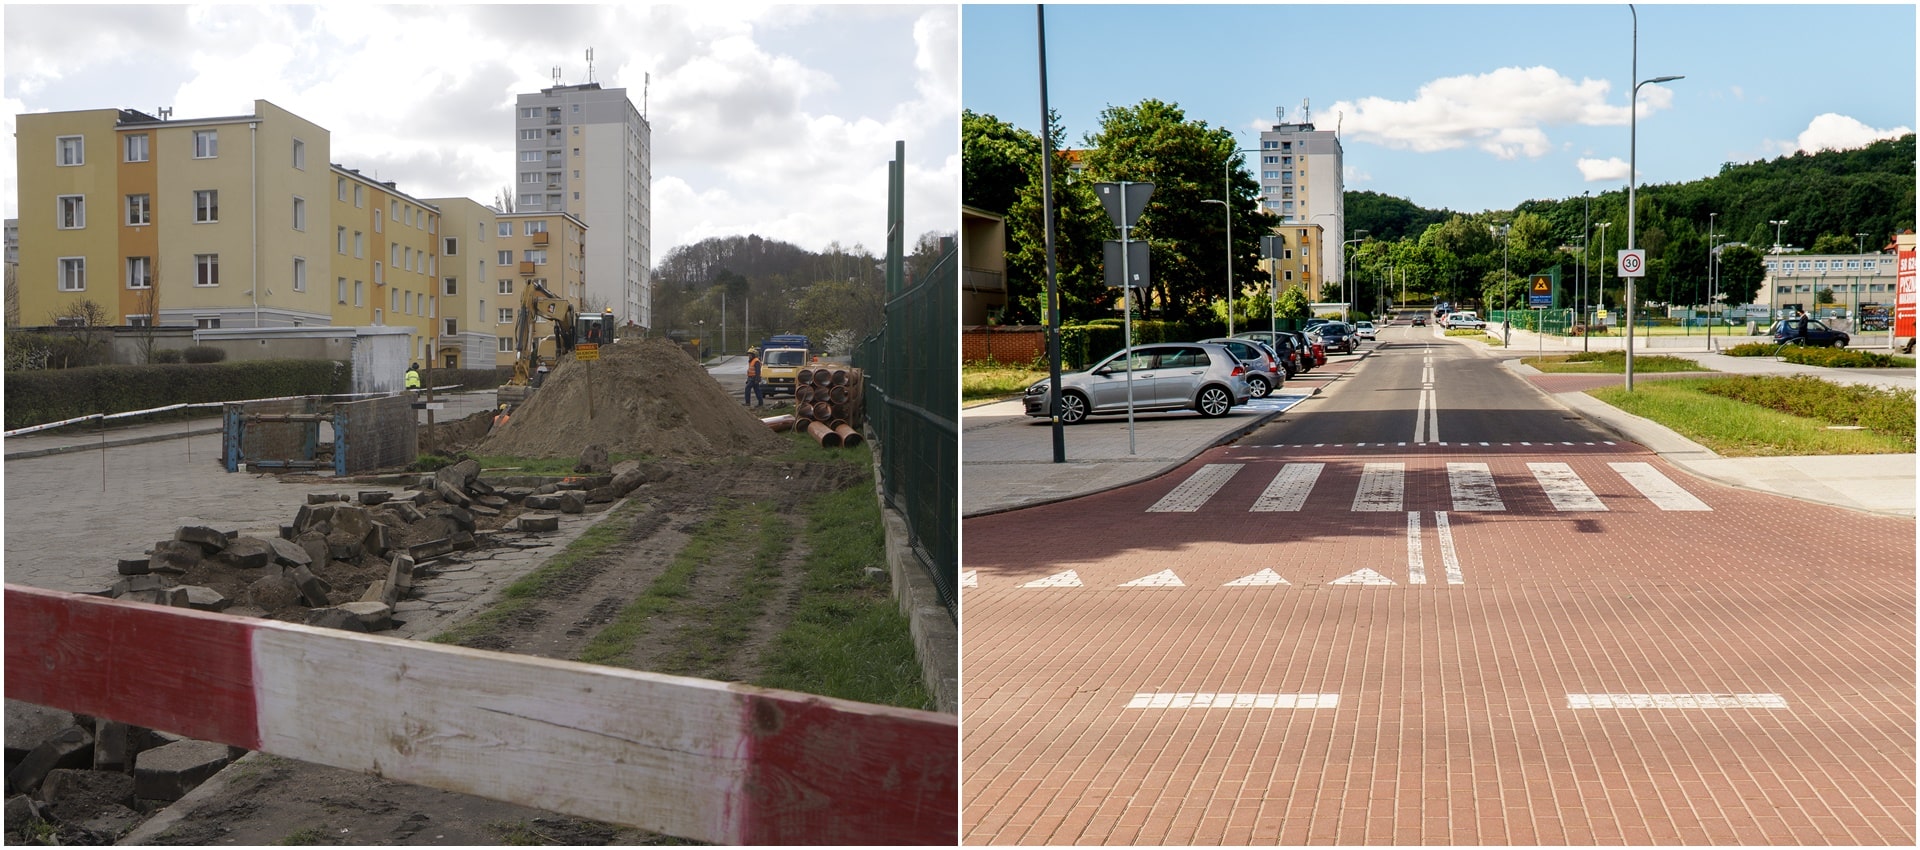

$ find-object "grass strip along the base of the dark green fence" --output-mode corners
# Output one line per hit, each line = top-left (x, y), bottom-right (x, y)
(755, 484), (935, 710)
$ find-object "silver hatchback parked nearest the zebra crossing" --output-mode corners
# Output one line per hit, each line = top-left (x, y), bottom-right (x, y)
(1025, 342), (1252, 424)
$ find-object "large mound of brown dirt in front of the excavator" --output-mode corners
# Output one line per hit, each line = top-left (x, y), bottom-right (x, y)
(472, 340), (787, 459)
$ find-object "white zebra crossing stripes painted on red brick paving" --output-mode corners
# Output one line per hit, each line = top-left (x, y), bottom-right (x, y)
(1146, 460), (1713, 514)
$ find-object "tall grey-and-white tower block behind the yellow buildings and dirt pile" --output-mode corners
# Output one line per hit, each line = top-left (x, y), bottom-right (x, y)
(513, 83), (653, 328)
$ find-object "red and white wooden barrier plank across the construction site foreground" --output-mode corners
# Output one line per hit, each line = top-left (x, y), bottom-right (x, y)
(6, 585), (960, 844)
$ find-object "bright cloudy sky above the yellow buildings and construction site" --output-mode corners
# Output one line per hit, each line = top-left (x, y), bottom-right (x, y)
(0, 2), (960, 261)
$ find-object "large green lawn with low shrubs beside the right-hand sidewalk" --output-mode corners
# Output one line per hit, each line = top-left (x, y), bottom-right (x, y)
(1588, 376), (1914, 457)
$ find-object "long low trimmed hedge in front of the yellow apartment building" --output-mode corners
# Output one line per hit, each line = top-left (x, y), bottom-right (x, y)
(6, 361), (353, 430)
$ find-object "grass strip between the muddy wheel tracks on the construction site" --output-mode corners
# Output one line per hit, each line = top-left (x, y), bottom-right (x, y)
(578, 503), (793, 679)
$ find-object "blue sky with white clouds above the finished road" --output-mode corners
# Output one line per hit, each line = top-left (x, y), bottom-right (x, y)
(960, 2), (1916, 213)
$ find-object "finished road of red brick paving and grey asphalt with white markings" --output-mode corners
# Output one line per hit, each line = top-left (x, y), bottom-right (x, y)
(962, 328), (1914, 844)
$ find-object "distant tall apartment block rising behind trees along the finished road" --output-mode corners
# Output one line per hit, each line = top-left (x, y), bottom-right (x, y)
(1260, 106), (1346, 301)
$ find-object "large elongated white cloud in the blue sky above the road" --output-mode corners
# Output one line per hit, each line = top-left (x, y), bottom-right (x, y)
(1329, 67), (1672, 159)
